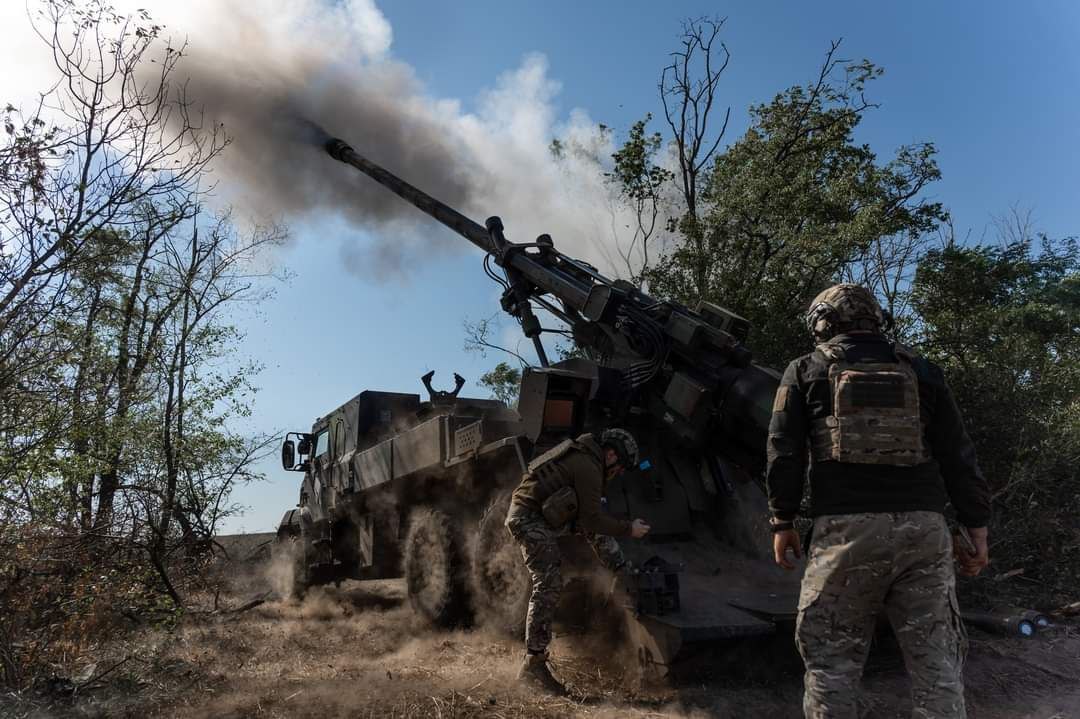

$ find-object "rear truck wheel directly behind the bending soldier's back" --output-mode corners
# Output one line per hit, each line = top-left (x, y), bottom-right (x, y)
(472, 492), (532, 638)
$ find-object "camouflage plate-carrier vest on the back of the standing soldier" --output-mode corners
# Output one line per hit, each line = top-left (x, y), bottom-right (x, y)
(810, 343), (930, 466)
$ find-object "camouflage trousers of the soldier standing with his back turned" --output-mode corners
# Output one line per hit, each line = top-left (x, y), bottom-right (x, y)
(795, 512), (967, 719)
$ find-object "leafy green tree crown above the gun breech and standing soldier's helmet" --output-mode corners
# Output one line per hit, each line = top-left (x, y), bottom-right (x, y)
(647, 60), (945, 366)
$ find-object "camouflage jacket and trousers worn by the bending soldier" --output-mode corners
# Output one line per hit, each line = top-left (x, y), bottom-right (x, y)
(505, 435), (630, 654)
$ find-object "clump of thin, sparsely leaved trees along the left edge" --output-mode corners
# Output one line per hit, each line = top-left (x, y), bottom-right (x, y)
(0, 0), (285, 656)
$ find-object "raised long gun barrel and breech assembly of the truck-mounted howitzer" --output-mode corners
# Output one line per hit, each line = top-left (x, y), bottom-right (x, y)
(326, 139), (777, 472)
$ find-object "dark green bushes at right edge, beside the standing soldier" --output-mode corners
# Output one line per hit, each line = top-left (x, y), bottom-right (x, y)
(913, 238), (1080, 591)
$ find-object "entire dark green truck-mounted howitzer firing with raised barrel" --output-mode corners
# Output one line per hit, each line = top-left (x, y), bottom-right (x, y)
(278, 139), (798, 671)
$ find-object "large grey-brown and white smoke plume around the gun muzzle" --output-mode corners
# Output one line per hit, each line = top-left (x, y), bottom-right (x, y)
(115, 0), (639, 276)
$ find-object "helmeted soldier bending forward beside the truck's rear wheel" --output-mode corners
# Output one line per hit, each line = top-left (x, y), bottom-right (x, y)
(505, 429), (649, 693)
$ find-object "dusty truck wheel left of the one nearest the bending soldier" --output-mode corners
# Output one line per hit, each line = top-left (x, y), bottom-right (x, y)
(405, 507), (469, 626)
